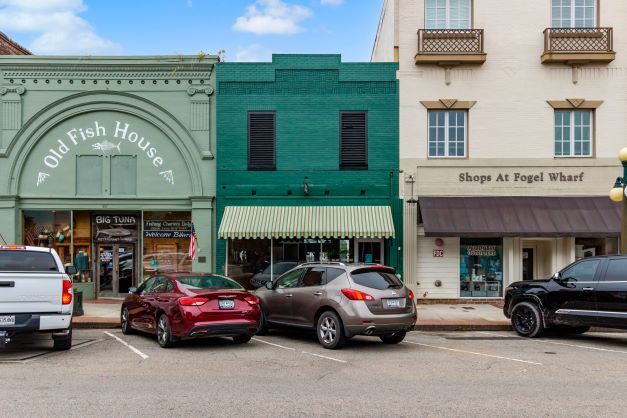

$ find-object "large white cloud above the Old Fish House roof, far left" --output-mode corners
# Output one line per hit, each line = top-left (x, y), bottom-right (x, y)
(0, 0), (122, 55)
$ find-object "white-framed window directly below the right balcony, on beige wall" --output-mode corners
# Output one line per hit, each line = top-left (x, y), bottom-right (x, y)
(555, 110), (592, 157)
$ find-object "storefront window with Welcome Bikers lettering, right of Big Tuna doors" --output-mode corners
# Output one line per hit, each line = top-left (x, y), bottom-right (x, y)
(142, 212), (192, 280)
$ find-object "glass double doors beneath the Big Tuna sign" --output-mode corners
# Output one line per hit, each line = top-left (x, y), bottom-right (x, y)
(96, 244), (135, 297)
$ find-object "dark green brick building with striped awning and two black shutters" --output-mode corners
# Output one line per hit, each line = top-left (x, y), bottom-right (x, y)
(216, 55), (402, 285)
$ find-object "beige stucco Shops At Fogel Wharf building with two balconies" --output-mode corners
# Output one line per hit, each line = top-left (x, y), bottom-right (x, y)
(372, 0), (627, 299)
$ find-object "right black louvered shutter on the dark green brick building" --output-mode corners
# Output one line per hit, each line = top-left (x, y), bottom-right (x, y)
(340, 112), (368, 170)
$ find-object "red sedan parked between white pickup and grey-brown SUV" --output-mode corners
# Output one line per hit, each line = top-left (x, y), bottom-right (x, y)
(121, 273), (261, 348)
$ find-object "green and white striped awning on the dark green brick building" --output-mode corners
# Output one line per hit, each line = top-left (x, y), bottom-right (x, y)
(218, 206), (394, 239)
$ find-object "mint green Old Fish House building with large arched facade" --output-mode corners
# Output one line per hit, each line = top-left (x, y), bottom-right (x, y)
(0, 56), (217, 297)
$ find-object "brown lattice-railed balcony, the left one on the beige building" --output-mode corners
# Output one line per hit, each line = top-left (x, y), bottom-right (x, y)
(416, 29), (487, 66)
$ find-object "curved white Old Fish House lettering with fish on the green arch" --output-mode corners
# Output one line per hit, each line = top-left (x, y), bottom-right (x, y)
(37, 121), (174, 187)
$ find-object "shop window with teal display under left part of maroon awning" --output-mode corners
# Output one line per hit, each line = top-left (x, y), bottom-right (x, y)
(459, 238), (503, 297)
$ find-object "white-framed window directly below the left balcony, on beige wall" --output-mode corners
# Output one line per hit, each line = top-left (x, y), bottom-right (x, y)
(428, 110), (468, 158)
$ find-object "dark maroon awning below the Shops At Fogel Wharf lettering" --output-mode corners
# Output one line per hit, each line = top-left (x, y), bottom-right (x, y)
(419, 196), (621, 238)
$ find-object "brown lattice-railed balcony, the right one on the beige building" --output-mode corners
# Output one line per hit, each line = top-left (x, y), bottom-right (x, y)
(541, 28), (616, 64)
